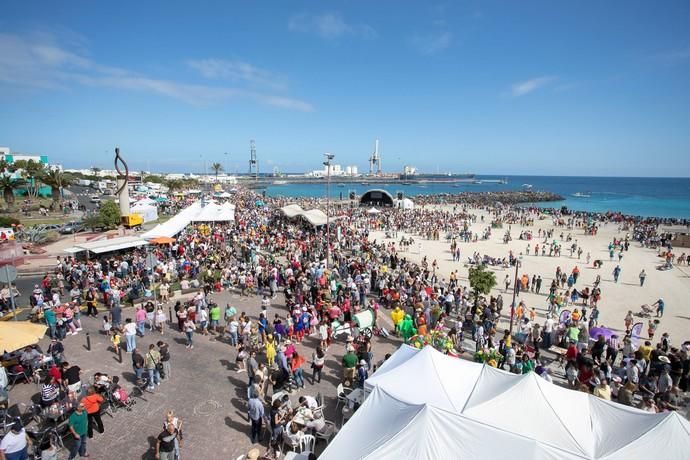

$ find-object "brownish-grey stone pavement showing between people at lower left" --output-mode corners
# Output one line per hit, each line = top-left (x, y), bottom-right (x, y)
(10, 292), (400, 460)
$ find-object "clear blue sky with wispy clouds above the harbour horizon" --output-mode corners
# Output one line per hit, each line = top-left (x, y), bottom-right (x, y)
(0, 1), (690, 176)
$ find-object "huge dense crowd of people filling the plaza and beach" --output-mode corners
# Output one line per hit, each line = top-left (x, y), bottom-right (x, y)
(1, 191), (690, 459)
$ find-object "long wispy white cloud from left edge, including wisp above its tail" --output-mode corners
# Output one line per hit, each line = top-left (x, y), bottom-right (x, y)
(0, 34), (314, 111)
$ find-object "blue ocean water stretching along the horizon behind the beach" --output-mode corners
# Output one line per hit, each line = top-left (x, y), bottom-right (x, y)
(266, 176), (690, 219)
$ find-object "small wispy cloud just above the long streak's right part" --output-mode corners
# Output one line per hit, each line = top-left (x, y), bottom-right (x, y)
(187, 59), (287, 89)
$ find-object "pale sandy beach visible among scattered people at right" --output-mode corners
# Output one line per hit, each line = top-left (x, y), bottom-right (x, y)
(370, 206), (690, 344)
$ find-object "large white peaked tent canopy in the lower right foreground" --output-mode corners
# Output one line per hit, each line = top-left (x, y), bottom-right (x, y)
(320, 345), (690, 460)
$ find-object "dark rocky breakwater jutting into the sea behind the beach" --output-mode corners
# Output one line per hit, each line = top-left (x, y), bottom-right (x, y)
(412, 190), (565, 205)
